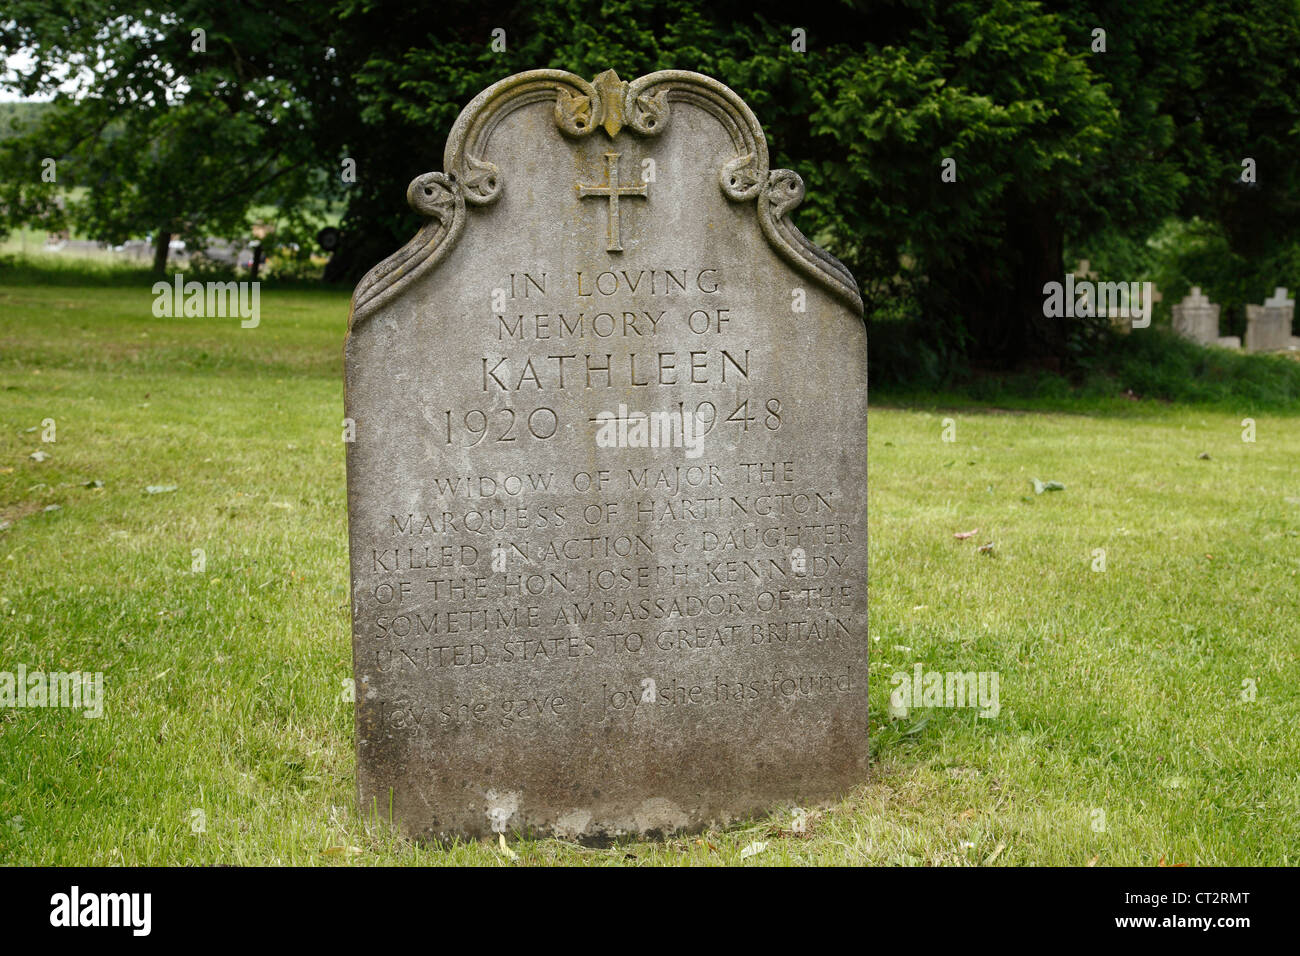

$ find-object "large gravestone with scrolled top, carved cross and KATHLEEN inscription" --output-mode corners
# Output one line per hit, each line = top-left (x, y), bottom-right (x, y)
(346, 70), (867, 842)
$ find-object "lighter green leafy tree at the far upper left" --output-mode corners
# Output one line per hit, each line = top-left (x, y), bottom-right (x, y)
(0, 0), (337, 272)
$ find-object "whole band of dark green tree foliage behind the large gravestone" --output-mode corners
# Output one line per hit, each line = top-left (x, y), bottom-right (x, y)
(0, 0), (1300, 369)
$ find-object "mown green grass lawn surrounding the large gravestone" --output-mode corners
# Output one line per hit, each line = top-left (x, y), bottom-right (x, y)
(0, 278), (1300, 865)
